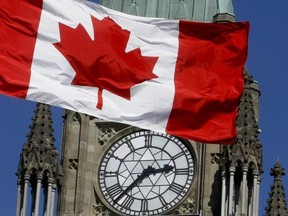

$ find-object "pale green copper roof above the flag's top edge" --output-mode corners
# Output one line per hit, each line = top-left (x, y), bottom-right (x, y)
(100, 0), (234, 22)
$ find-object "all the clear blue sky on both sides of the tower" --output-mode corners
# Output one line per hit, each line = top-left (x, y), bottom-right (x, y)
(0, 0), (288, 216)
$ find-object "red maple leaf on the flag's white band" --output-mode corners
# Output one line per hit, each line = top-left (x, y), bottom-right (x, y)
(54, 16), (158, 109)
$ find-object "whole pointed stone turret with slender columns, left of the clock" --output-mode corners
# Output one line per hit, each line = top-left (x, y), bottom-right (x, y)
(16, 104), (61, 216)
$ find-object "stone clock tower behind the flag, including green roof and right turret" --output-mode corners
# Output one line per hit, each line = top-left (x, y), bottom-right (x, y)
(57, 0), (262, 216)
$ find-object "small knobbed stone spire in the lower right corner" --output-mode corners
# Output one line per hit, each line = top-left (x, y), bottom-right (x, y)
(265, 161), (288, 216)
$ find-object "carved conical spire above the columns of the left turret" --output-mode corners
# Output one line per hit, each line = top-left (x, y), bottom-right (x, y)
(17, 103), (58, 181)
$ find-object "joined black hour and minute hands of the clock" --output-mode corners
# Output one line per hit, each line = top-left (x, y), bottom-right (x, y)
(113, 164), (174, 204)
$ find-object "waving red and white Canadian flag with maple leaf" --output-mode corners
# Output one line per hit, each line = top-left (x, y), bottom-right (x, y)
(0, 0), (249, 143)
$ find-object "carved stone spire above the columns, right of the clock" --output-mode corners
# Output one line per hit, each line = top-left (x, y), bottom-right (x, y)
(223, 69), (263, 173)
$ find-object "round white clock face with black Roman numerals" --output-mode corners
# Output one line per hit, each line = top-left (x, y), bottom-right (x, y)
(98, 131), (194, 215)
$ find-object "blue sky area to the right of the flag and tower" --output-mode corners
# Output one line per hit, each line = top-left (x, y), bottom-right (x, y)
(234, 0), (288, 216)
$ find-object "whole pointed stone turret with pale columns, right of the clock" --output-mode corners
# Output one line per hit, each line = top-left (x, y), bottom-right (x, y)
(222, 69), (262, 215)
